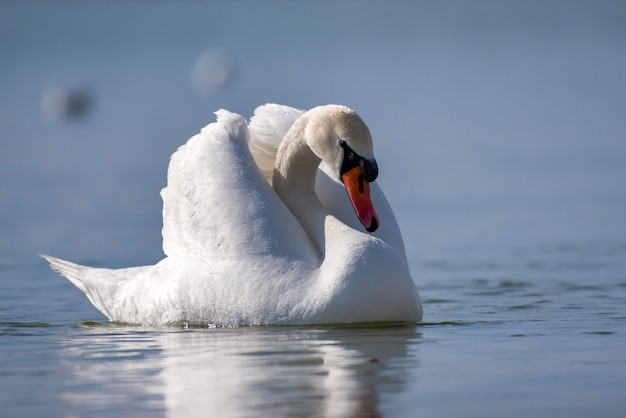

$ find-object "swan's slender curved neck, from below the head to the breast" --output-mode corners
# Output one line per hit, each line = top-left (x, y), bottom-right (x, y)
(272, 118), (328, 258)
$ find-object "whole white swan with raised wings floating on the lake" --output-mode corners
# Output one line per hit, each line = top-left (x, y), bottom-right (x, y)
(41, 104), (422, 326)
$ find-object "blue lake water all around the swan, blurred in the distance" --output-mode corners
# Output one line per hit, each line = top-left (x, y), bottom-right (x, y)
(0, 0), (626, 417)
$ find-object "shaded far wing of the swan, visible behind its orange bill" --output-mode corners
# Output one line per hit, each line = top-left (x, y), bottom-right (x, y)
(315, 162), (407, 261)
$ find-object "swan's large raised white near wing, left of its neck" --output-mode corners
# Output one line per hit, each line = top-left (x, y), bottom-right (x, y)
(161, 110), (315, 260)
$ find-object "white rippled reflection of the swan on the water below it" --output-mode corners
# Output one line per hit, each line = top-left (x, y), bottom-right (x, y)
(59, 325), (420, 417)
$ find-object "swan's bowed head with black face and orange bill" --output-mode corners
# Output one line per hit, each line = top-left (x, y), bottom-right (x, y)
(306, 105), (379, 232)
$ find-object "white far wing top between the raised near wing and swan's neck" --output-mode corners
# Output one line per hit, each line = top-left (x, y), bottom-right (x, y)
(249, 103), (304, 182)
